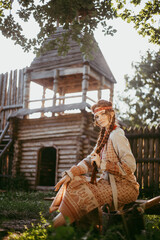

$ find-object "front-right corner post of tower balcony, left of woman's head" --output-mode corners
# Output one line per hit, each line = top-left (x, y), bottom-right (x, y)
(82, 63), (90, 102)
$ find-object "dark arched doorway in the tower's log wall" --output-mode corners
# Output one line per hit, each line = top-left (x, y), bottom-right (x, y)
(37, 147), (57, 186)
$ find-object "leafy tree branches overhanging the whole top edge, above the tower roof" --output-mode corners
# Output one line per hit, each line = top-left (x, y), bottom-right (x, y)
(0, 0), (160, 56)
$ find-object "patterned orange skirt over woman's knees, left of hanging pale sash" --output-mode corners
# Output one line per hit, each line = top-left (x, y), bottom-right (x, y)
(59, 176), (112, 222)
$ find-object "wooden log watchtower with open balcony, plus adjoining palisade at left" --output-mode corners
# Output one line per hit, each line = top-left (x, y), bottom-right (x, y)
(0, 28), (116, 189)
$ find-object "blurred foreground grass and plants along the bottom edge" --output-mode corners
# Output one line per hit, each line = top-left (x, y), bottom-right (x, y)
(8, 215), (160, 240)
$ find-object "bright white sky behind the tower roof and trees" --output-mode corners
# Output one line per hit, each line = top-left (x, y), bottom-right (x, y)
(0, 8), (158, 106)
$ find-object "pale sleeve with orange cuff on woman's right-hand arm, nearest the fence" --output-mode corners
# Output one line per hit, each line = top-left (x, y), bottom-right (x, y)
(106, 129), (136, 175)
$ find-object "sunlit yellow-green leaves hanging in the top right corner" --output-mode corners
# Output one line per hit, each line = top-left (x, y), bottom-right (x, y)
(117, 0), (160, 45)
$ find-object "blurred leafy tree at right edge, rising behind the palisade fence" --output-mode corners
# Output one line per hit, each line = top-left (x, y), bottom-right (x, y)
(117, 51), (160, 126)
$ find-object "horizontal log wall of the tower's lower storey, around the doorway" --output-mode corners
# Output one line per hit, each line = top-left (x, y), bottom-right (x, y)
(12, 114), (97, 188)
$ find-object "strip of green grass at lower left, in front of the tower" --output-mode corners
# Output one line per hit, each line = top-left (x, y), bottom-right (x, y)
(0, 191), (54, 221)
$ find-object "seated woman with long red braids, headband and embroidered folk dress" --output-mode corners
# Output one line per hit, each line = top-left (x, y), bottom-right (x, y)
(50, 100), (139, 227)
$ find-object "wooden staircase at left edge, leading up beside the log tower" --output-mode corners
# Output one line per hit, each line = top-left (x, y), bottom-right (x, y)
(0, 122), (12, 160)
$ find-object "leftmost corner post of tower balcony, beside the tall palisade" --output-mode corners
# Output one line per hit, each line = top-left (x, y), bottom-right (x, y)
(23, 68), (30, 117)
